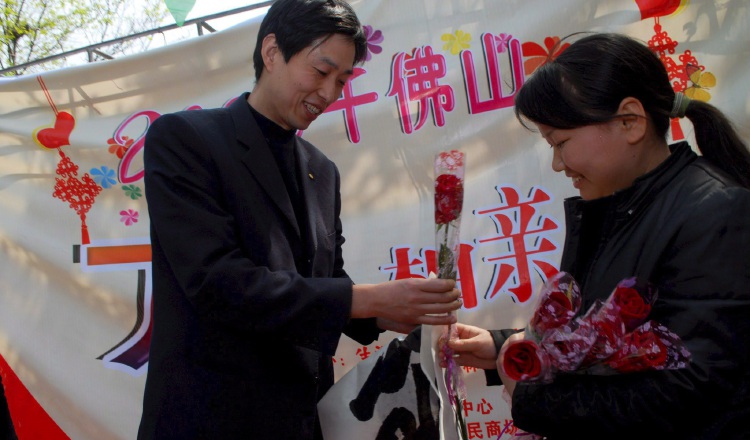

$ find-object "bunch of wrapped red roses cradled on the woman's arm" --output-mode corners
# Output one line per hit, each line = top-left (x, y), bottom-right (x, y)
(500, 272), (691, 382)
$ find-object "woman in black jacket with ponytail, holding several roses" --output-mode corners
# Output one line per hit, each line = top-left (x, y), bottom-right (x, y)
(450, 34), (750, 440)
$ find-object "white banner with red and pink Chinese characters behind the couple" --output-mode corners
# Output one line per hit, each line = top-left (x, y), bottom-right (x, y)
(0, 0), (750, 440)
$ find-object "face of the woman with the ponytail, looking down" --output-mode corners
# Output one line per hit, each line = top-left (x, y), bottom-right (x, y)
(536, 119), (642, 200)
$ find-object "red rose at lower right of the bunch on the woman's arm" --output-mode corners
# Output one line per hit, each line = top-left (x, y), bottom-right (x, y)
(607, 327), (668, 373)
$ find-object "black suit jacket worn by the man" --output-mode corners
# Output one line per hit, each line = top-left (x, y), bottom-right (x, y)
(138, 94), (379, 439)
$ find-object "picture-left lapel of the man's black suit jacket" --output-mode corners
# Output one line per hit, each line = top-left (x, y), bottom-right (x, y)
(229, 93), (300, 236)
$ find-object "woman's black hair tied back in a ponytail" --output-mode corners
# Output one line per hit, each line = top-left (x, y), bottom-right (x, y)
(515, 33), (750, 188)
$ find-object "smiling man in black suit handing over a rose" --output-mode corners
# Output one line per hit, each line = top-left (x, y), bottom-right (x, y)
(138, 0), (461, 440)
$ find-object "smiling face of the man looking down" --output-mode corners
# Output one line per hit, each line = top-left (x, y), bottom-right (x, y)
(256, 34), (354, 130)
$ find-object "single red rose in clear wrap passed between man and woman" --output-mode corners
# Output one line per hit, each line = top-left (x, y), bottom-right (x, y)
(435, 150), (469, 440)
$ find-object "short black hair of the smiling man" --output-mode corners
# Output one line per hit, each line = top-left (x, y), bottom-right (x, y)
(253, 0), (367, 80)
